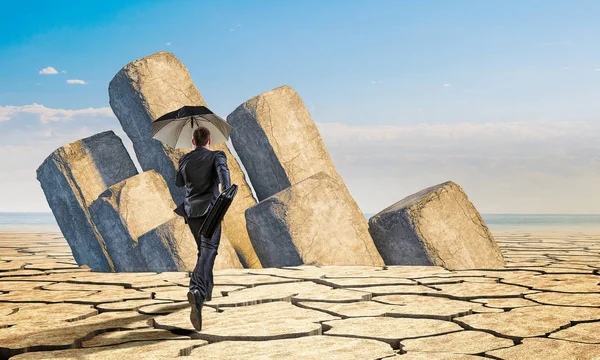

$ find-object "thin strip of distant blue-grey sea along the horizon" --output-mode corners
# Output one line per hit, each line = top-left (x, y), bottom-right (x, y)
(0, 212), (600, 232)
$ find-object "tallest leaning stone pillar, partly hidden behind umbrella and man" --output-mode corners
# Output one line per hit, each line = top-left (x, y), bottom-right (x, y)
(108, 51), (261, 268)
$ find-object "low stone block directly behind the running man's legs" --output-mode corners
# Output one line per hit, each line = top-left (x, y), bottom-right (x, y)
(139, 216), (242, 272)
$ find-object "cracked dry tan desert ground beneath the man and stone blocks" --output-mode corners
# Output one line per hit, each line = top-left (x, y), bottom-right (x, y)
(0, 232), (600, 360)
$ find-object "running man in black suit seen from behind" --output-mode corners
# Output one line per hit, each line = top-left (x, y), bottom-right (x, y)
(175, 127), (230, 331)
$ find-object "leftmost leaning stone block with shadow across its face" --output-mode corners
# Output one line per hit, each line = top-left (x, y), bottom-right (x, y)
(37, 131), (137, 271)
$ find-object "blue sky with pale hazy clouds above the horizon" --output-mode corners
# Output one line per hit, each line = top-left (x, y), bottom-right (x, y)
(0, 0), (600, 213)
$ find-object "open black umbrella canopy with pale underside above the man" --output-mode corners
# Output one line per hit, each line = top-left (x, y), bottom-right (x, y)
(152, 106), (231, 149)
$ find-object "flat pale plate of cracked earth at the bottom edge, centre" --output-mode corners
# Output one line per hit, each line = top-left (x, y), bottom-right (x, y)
(191, 335), (394, 360)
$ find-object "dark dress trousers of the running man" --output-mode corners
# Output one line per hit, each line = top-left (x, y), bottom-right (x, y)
(187, 216), (221, 299)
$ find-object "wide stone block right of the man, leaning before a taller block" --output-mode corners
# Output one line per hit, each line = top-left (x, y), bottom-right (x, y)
(246, 172), (383, 267)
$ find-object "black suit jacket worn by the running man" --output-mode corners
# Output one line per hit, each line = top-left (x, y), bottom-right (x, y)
(174, 147), (230, 221)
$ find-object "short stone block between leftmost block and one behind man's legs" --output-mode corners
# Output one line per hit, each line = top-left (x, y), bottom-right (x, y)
(90, 170), (177, 271)
